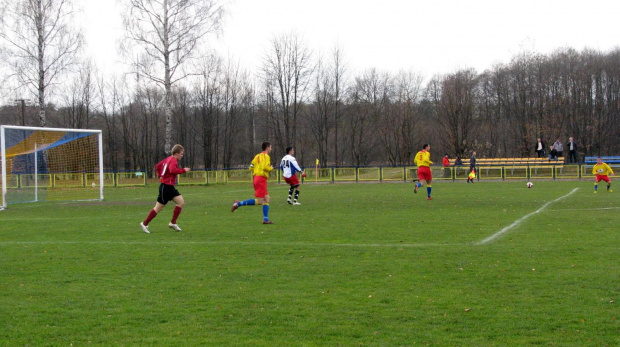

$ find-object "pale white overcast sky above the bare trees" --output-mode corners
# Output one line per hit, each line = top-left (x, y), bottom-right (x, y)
(80, 0), (620, 77)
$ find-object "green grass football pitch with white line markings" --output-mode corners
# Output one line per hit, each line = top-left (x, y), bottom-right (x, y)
(0, 181), (620, 346)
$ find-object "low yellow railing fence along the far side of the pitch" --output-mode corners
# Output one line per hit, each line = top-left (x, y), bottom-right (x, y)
(7, 163), (620, 188)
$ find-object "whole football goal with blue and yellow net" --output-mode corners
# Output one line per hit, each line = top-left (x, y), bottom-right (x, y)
(0, 125), (103, 208)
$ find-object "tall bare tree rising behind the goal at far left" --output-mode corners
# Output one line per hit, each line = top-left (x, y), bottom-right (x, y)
(0, 0), (83, 126)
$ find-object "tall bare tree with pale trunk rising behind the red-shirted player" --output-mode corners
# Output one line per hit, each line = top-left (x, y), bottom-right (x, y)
(124, 0), (224, 152)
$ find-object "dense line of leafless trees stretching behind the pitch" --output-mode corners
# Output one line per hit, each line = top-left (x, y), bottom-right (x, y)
(0, 47), (620, 170)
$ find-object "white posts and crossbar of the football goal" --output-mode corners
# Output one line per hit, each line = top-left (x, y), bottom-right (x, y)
(0, 125), (104, 211)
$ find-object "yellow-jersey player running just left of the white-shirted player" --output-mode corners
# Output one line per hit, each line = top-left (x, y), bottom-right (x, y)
(231, 142), (273, 224)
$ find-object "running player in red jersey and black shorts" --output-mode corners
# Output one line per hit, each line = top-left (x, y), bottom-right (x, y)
(140, 145), (190, 234)
